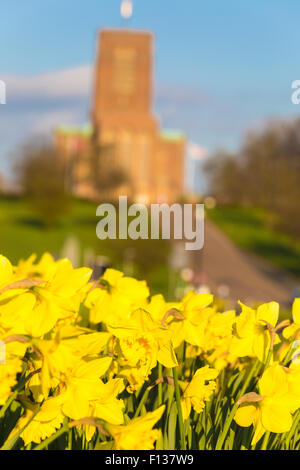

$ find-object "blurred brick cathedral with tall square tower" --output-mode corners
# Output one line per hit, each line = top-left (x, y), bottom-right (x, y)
(55, 29), (185, 204)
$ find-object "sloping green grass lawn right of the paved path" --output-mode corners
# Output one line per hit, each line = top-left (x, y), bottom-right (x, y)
(207, 206), (300, 278)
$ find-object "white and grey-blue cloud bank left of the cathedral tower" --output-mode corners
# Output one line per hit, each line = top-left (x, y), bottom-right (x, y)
(0, 65), (92, 176)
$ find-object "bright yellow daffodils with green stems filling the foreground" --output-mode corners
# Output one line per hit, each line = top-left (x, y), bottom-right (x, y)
(0, 253), (300, 450)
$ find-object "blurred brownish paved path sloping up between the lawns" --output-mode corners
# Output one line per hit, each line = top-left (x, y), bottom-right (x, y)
(193, 219), (300, 306)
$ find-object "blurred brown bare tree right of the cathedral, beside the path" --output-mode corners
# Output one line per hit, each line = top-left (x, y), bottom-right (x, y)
(205, 118), (300, 235)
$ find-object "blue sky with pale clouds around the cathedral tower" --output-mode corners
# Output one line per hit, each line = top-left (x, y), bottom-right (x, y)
(0, 0), (300, 191)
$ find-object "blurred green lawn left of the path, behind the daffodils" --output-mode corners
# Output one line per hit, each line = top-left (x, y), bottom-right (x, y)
(0, 197), (169, 296)
